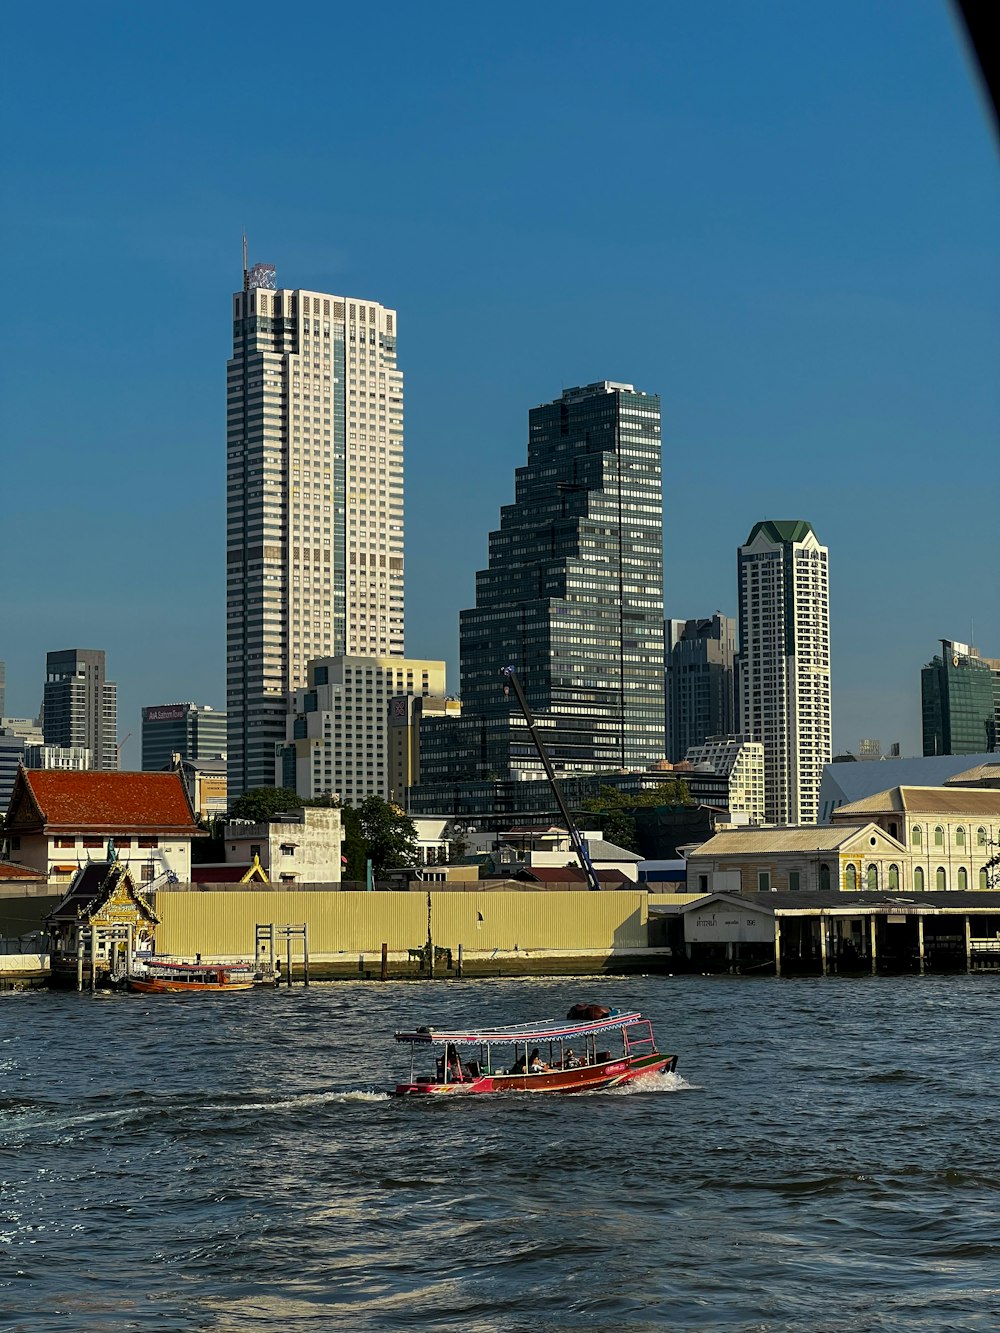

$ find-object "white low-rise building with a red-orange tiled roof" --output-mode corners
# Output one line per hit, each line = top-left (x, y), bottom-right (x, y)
(4, 768), (201, 884)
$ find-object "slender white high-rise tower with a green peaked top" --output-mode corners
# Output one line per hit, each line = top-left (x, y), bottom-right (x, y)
(739, 519), (832, 824)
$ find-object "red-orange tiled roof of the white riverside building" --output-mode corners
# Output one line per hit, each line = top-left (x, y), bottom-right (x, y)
(7, 768), (200, 836)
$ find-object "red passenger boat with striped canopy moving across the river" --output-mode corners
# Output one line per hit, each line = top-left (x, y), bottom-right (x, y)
(396, 1005), (677, 1097)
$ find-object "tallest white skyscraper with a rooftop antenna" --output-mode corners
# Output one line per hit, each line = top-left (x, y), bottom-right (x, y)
(227, 264), (404, 797)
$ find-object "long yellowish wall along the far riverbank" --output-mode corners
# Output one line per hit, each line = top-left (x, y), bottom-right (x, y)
(148, 886), (647, 957)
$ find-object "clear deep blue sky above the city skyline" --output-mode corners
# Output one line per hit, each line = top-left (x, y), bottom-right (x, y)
(0, 0), (1000, 766)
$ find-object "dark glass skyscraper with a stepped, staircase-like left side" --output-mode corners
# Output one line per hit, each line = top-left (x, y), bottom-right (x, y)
(420, 381), (664, 784)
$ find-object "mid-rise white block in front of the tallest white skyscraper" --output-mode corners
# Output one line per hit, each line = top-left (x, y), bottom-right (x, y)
(276, 656), (445, 805)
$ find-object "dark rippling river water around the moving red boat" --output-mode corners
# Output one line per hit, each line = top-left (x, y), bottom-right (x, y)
(0, 976), (1000, 1333)
